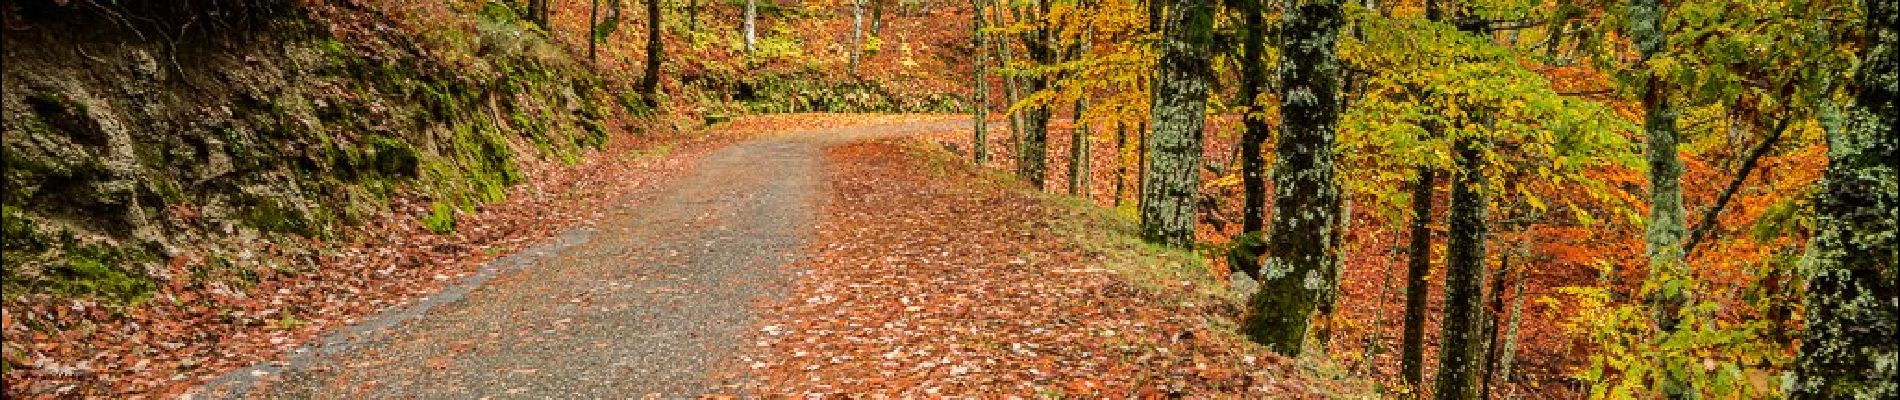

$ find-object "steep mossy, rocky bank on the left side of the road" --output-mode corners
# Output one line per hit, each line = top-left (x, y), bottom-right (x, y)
(0, 0), (644, 303)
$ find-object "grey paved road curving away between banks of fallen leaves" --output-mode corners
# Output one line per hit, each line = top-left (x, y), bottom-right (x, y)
(194, 121), (967, 398)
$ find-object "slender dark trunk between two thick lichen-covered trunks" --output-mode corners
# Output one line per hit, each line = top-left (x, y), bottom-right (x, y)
(1239, 0), (1269, 234)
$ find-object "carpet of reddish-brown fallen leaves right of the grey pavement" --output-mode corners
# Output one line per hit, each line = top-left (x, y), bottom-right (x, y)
(743, 142), (1326, 398)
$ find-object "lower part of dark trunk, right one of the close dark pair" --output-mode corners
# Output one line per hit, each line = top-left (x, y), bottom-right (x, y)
(1433, 138), (1488, 398)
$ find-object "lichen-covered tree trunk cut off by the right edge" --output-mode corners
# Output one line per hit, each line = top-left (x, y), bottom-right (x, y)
(1790, 0), (1900, 398)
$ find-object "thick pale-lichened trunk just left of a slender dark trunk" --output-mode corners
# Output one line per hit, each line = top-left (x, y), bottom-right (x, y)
(1142, 0), (1214, 248)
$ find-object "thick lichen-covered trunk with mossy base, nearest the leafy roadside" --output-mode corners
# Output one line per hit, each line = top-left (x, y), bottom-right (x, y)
(1241, 0), (1343, 356)
